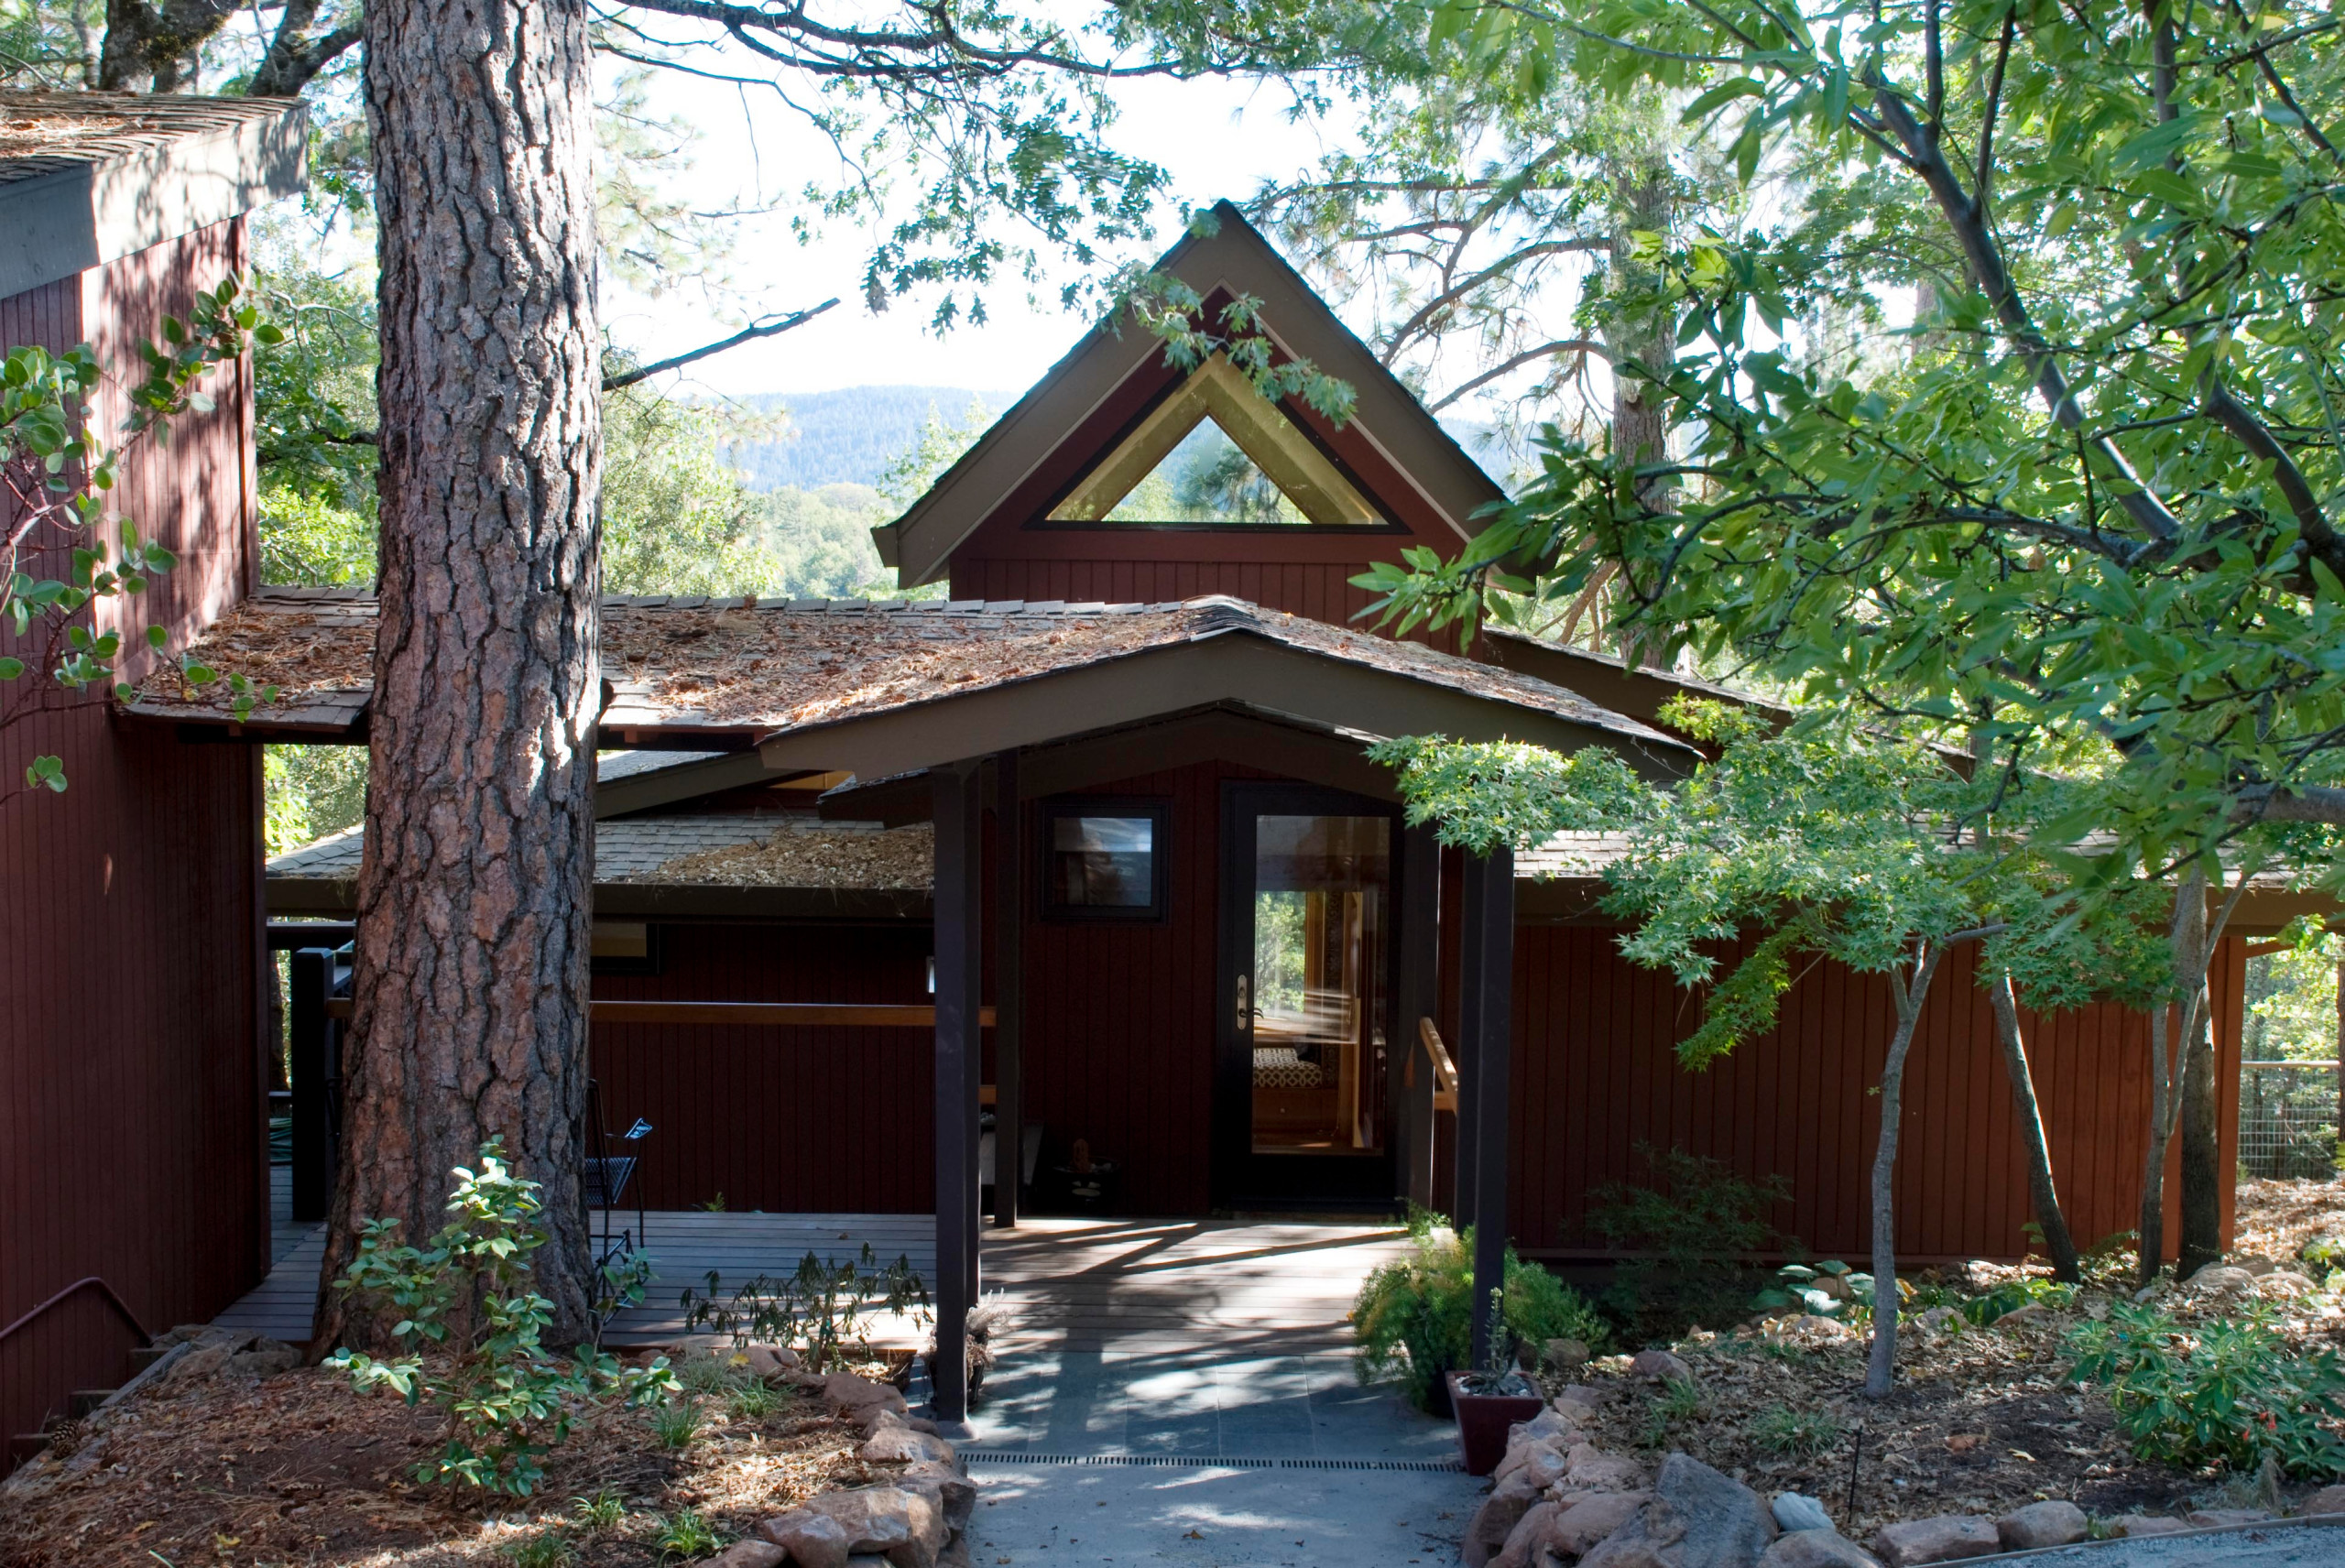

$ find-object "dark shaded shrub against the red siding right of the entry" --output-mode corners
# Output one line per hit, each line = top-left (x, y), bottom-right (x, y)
(1587, 1144), (1792, 1343)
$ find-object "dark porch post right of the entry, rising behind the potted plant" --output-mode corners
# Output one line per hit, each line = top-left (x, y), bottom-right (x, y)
(1458, 848), (1515, 1367)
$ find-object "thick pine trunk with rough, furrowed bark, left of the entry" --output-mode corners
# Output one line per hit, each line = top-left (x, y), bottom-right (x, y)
(319, 0), (603, 1347)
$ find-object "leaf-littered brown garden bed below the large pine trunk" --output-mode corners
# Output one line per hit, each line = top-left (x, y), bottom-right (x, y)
(0, 1340), (900, 1568)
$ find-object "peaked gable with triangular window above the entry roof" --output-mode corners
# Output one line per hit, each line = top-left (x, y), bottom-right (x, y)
(875, 201), (1503, 591)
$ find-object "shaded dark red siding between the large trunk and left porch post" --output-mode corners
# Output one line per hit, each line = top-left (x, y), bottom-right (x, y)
(594, 923), (935, 1214)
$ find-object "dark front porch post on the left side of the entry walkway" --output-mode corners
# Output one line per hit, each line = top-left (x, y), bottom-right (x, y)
(929, 762), (985, 1421)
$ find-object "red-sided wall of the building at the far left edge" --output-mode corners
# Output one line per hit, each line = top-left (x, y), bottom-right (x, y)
(0, 223), (267, 1462)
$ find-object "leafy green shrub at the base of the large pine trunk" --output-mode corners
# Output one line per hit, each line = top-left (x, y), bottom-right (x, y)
(326, 1139), (673, 1496)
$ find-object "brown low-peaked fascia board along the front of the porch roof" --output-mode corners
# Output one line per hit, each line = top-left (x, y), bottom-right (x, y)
(758, 630), (1674, 779)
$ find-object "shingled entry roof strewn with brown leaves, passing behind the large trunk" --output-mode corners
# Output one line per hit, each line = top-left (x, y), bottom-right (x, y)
(129, 591), (1696, 776)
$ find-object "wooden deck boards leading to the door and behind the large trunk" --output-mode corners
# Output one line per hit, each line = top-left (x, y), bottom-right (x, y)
(218, 1212), (1404, 1355)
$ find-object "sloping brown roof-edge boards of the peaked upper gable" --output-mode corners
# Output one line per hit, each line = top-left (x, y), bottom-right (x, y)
(872, 201), (1506, 586)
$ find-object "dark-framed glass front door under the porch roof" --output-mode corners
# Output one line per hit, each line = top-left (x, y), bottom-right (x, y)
(1217, 785), (1398, 1207)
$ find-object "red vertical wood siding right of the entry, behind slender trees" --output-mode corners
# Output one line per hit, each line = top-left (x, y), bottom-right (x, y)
(1508, 926), (2240, 1258)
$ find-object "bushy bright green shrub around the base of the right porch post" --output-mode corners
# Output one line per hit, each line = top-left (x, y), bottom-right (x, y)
(1351, 1207), (1607, 1409)
